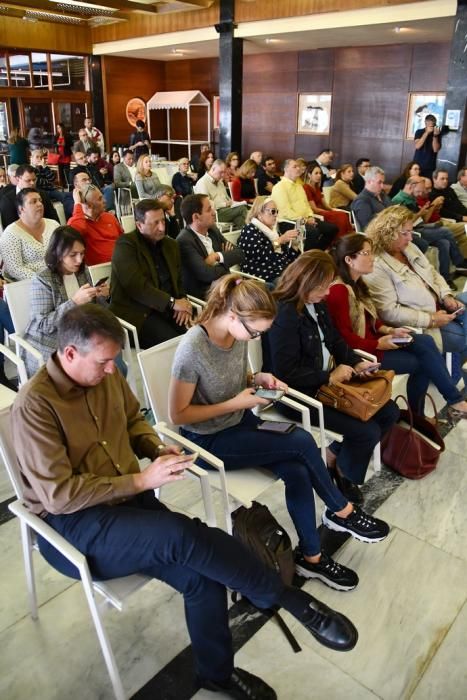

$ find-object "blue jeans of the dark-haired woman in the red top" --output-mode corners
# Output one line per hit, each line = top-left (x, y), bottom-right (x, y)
(381, 334), (462, 415)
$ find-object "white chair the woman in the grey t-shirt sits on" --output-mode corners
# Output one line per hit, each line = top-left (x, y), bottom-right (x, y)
(138, 338), (316, 533)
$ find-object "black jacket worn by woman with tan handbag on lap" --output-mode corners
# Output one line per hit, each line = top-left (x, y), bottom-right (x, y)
(263, 301), (362, 396)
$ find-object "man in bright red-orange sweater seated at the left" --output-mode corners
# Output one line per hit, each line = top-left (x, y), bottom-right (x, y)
(68, 183), (123, 265)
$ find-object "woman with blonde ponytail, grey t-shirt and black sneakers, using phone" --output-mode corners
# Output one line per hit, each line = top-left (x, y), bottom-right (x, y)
(169, 274), (389, 590)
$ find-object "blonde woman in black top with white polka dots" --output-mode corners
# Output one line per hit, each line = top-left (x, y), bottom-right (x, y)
(237, 197), (300, 289)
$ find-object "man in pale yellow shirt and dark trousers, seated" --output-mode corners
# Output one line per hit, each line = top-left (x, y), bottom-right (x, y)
(271, 158), (338, 250)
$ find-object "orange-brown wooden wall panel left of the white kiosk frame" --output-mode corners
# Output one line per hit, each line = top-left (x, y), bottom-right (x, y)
(102, 56), (165, 147)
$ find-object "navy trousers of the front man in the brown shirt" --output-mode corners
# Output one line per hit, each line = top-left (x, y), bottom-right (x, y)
(43, 491), (284, 681)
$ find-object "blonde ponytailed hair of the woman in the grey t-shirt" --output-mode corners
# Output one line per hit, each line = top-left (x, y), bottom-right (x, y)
(197, 273), (276, 323)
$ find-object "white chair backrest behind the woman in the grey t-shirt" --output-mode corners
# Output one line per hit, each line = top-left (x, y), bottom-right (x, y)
(138, 337), (181, 432)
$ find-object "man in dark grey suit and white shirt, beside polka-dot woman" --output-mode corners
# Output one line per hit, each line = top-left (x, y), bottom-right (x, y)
(177, 194), (244, 299)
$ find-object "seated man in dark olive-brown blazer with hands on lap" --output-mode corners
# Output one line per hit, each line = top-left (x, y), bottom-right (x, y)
(110, 199), (192, 348)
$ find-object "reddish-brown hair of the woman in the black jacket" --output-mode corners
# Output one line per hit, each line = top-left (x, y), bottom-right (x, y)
(273, 250), (336, 311)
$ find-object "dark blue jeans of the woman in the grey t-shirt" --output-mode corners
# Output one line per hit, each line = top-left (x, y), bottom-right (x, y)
(180, 411), (348, 556)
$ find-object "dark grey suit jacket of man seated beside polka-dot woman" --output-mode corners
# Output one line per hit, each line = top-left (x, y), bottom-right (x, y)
(177, 227), (244, 299)
